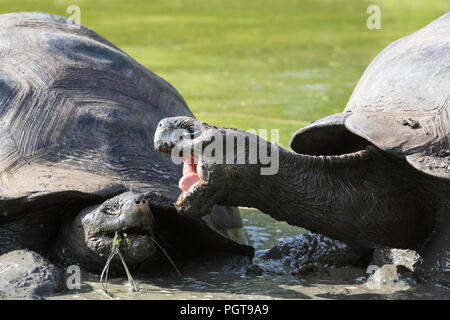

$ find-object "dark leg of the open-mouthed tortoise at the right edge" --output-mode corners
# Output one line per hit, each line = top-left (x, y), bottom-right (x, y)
(414, 205), (450, 287)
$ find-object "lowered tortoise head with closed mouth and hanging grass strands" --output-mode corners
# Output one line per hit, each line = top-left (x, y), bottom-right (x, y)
(62, 192), (157, 271)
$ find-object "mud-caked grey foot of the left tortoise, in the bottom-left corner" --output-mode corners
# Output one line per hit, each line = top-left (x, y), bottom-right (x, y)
(0, 249), (60, 299)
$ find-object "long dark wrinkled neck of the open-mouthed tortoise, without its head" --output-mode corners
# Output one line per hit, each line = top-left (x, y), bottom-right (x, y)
(241, 145), (442, 249)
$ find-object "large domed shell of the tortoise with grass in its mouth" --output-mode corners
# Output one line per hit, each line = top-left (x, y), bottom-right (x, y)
(0, 13), (188, 199)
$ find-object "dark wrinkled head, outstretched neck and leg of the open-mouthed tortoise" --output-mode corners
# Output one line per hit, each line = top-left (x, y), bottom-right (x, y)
(154, 117), (450, 285)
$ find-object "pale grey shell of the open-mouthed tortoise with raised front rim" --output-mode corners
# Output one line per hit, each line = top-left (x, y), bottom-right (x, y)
(291, 13), (450, 179)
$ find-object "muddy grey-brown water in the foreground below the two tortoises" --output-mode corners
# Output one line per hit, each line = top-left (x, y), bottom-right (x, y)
(52, 209), (450, 300)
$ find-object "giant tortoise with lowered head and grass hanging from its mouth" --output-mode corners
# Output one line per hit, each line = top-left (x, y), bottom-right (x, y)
(0, 13), (253, 296)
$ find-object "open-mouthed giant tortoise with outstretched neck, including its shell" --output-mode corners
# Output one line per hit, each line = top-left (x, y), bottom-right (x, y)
(155, 13), (450, 285)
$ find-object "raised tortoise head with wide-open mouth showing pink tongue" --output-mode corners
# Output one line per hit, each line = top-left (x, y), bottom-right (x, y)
(154, 116), (278, 218)
